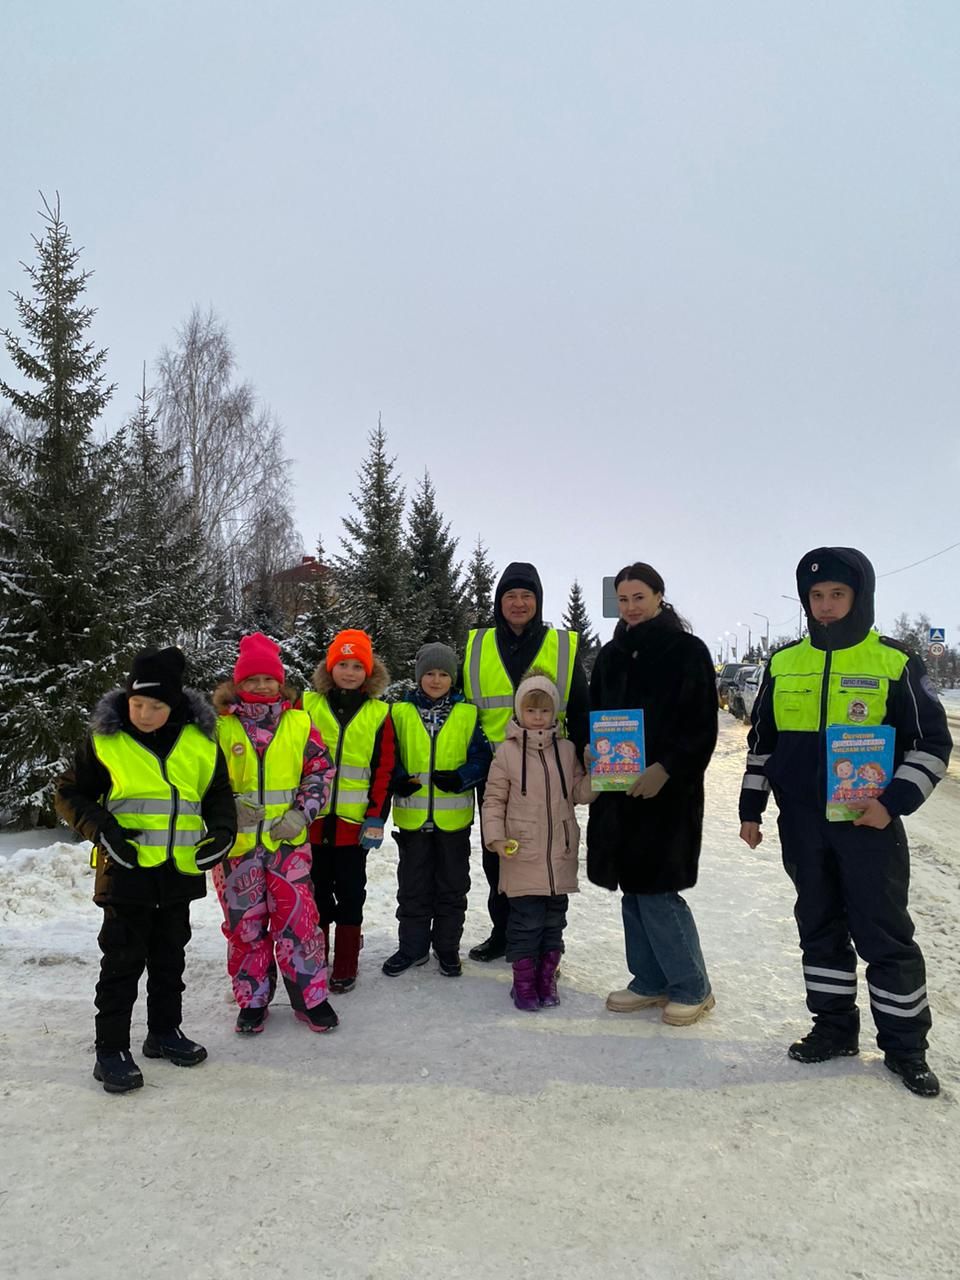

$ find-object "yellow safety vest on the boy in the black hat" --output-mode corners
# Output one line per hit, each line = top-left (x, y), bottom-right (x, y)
(92, 724), (216, 876)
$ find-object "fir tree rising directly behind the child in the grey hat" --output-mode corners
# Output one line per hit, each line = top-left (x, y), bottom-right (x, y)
(407, 471), (467, 654)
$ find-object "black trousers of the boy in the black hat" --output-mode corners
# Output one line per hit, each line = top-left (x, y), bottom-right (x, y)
(95, 902), (189, 1053)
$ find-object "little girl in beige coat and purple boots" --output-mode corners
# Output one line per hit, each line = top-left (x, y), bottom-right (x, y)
(483, 675), (593, 1011)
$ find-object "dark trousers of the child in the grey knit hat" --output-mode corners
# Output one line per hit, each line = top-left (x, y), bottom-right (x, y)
(394, 827), (470, 959)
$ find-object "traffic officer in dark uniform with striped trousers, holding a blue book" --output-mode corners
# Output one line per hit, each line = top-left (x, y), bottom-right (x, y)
(740, 547), (952, 1097)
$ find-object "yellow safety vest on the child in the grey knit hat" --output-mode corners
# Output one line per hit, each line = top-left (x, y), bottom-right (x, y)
(390, 703), (479, 831)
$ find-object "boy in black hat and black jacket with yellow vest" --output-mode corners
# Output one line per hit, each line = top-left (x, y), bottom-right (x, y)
(56, 649), (237, 1093)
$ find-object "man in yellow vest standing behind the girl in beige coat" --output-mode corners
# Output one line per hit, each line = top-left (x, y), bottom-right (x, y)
(462, 561), (590, 960)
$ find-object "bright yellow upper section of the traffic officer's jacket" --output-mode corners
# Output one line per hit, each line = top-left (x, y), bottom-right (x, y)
(771, 631), (908, 733)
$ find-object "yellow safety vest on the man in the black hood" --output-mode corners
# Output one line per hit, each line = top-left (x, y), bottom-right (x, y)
(463, 627), (580, 744)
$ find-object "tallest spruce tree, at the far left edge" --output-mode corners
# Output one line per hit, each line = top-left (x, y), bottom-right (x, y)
(0, 198), (118, 823)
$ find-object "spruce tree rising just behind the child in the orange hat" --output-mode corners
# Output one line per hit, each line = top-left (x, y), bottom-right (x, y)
(334, 419), (420, 680)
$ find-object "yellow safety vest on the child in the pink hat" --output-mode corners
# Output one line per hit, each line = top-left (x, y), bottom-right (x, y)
(216, 710), (310, 858)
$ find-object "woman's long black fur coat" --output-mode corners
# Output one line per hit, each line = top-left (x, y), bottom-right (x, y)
(586, 609), (717, 893)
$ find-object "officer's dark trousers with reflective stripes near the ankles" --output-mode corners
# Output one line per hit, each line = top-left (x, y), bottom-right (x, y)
(778, 803), (931, 1055)
